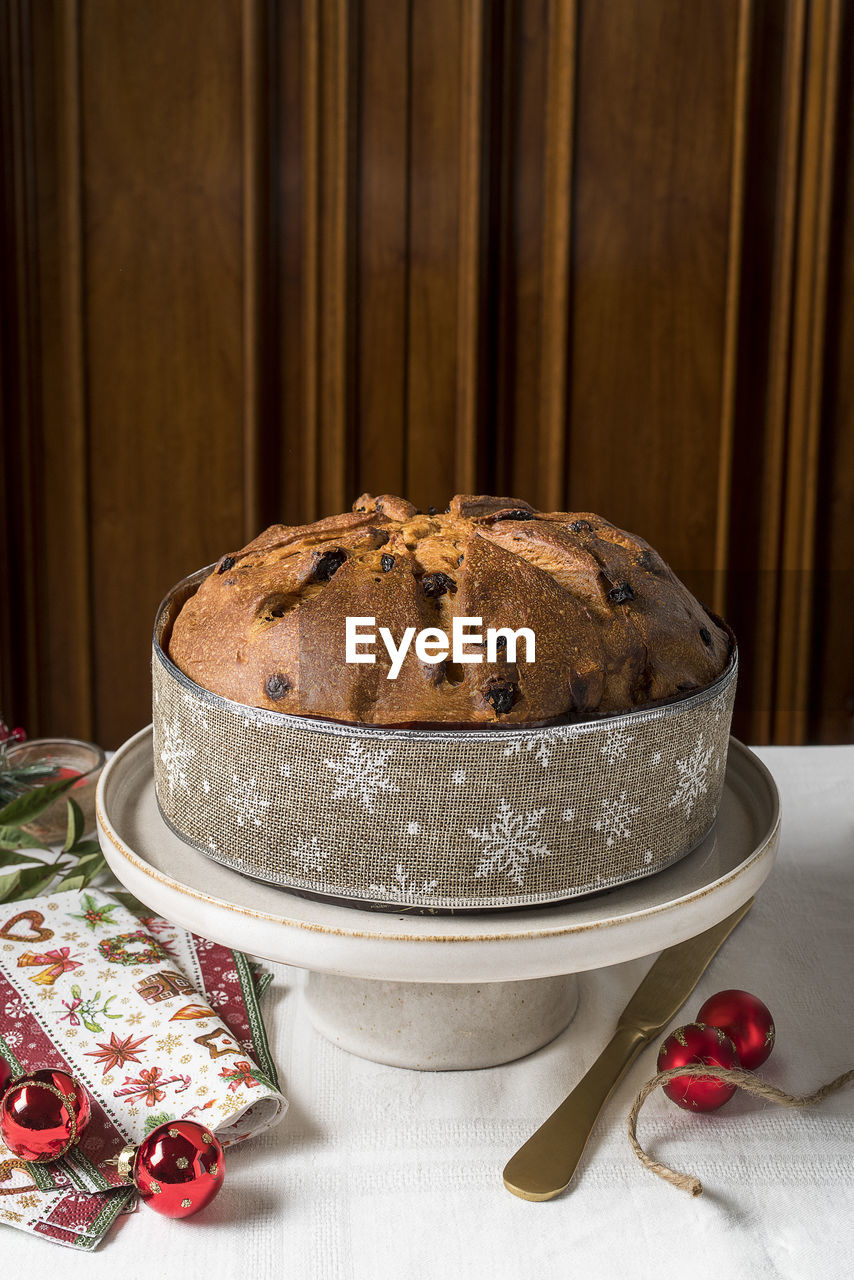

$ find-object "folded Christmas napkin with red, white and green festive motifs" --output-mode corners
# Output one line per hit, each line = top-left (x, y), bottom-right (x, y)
(0, 888), (288, 1249)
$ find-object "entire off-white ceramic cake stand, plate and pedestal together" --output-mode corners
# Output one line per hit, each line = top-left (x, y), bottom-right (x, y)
(96, 727), (780, 1070)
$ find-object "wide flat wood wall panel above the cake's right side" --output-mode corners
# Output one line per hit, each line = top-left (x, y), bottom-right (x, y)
(567, 0), (739, 600)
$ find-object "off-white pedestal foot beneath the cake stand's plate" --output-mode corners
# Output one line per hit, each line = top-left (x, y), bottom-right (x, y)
(306, 973), (579, 1071)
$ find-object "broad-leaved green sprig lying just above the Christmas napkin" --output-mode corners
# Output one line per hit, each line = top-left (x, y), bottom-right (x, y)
(0, 777), (106, 902)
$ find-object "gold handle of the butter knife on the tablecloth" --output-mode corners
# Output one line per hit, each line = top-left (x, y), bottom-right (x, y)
(503, 1027), (647, 1201)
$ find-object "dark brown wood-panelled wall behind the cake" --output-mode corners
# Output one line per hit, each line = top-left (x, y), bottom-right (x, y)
(0, 0), (854, 746)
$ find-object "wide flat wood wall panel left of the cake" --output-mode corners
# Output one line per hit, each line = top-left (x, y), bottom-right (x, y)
(81, 0), (246, 746)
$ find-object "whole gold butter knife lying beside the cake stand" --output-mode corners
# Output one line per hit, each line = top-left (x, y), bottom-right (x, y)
(504, 899), (753, 1201)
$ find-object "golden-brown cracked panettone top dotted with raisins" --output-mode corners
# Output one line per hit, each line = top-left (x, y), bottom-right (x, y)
(168, 494), (732, 727)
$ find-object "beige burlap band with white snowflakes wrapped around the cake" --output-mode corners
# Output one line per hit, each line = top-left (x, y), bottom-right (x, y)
(152, 581), (737, 911)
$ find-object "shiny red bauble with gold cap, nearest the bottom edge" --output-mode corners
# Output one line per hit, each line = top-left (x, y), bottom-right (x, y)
(132, 1120), (225, 1217)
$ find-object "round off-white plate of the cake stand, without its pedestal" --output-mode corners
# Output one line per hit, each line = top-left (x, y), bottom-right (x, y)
(96, 726), (780, 983)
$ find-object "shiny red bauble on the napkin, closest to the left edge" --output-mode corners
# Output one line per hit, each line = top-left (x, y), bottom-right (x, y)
(0, 1070), (90, 1165)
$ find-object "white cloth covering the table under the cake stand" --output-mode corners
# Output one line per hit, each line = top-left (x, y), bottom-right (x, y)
(0, 746), (854, 1280)
